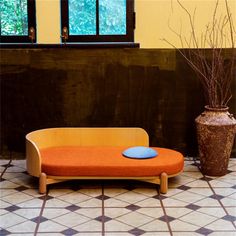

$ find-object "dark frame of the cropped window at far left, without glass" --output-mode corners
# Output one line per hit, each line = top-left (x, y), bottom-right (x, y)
(0, 0), (36, 43)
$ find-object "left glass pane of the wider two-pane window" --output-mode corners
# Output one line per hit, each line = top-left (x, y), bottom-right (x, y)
(69, 0), (96, 35)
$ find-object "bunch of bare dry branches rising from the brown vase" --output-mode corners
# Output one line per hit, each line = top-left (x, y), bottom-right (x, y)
(163, 0), (236, 107)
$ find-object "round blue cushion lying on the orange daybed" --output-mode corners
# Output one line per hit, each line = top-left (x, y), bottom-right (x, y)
(122, 146), (158, 159)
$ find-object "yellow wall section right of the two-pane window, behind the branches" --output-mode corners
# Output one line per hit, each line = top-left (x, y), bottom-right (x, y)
(135, 0), (236, 48)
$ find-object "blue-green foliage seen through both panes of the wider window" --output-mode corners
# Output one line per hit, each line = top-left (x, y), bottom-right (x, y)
(69, 0), (126, 35)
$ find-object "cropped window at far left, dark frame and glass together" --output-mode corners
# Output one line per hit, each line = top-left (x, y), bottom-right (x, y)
(0, 0), (36, 43)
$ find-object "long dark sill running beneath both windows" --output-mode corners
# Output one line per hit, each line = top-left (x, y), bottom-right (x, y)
(0, 42), (140, 49)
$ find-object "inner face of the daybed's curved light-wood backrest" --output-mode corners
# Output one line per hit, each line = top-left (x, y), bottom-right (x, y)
(26, 127), (149, 149)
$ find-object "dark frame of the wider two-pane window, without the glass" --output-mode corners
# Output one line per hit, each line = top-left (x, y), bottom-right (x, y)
(60, 0), (135, 43)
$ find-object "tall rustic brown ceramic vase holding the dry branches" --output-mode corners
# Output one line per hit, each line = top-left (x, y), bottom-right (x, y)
(195, 106), (236, 176)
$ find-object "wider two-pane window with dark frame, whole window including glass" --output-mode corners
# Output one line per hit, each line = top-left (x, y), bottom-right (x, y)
(61, 0), (134, 42)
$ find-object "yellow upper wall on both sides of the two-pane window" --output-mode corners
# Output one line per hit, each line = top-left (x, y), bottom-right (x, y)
(36, 0), (236, 48)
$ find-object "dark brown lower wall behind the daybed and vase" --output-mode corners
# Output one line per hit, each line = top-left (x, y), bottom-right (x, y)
(0, 48), (236, 156)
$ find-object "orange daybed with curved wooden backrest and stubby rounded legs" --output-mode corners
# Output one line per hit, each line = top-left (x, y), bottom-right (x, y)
(26, 128), (184, 193)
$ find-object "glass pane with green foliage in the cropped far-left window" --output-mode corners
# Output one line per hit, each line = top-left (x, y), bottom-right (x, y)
(0, 0), (28, 36)
